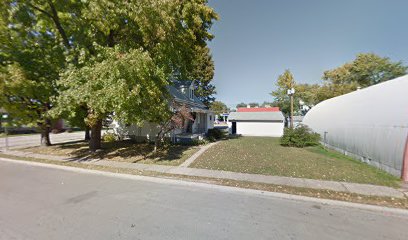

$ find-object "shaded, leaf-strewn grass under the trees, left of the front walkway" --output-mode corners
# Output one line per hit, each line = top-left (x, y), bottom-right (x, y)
(20, 141), (200, 166)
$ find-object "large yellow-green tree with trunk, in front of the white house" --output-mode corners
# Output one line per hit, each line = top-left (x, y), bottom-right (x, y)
(48, 0), (217, 150)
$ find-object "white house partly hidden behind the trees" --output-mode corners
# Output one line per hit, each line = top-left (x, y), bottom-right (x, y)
(112, 81), (215, 142)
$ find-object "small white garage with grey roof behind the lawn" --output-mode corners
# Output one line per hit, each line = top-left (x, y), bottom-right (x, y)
(228, 112), (285, 137)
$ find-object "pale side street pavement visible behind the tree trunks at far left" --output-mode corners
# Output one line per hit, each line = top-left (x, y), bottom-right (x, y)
(0, 131), (85, 150)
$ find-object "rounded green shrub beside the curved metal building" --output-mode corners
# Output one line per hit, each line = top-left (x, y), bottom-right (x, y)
(280, 125), (320, 148)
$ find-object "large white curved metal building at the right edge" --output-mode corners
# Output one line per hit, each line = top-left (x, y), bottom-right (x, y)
(303, 75), (408, 181)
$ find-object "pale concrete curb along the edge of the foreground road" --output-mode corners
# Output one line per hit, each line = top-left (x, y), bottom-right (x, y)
(0, 158), (408, 217)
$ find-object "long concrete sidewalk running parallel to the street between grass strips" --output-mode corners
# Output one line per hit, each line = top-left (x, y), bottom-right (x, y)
(4, 151), (407, 198)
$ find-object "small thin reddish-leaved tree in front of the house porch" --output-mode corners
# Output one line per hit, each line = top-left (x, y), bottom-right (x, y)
(153, 103), (194, 152)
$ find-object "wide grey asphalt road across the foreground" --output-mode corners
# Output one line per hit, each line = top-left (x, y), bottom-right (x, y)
(0, 161), (408, 240)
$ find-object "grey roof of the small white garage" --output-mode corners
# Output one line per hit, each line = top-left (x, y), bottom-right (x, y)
(228, 112), (285, 121)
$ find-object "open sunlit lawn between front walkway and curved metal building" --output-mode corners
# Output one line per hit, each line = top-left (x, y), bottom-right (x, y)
(191, 137), (399, 187)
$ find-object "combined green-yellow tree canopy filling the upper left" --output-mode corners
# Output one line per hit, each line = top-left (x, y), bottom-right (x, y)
(0, 0), (218, 148)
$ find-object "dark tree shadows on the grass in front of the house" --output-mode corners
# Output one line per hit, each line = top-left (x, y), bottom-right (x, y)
(54, 140), (191, 163)
